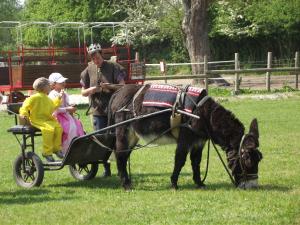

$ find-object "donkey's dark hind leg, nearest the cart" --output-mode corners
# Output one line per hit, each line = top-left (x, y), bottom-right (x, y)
(116, 126), (131, 189)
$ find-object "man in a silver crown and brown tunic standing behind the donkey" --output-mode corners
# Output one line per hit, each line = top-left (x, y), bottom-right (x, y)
(80, 44), (126, 177)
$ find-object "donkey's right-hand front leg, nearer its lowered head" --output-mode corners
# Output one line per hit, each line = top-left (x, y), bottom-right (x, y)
(190, 142), (205, 187)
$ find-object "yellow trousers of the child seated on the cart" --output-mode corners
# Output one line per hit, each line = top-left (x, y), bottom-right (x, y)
(39, 121), (63, 156)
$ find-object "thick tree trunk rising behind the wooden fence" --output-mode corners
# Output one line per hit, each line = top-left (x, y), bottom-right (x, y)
(182, 0), (211, 83)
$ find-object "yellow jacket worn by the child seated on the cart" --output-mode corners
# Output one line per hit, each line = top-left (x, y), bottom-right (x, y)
(20, 92), (61, 130)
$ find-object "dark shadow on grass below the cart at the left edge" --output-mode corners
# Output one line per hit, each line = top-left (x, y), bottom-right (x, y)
(0, 189), (74, 205)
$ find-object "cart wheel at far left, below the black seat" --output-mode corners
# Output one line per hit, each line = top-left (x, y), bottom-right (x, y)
(13, 152), (44, 188)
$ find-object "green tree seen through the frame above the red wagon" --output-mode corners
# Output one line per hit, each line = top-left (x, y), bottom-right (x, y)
(22, 0), (124, 47)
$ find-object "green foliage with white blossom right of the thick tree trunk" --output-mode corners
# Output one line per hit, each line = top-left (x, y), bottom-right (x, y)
(210, 0), (300, 60)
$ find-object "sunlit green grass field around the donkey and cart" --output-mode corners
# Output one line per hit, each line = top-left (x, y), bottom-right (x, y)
(0, 97), (300, 225)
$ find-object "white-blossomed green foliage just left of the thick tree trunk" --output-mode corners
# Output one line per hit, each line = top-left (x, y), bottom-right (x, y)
(113, 0), (188, 61)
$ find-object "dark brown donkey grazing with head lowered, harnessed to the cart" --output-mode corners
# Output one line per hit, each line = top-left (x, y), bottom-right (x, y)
(109, 84), (262, 189)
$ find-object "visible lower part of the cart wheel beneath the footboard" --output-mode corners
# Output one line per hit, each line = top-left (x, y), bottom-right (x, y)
(69, 163), (99, 180)
